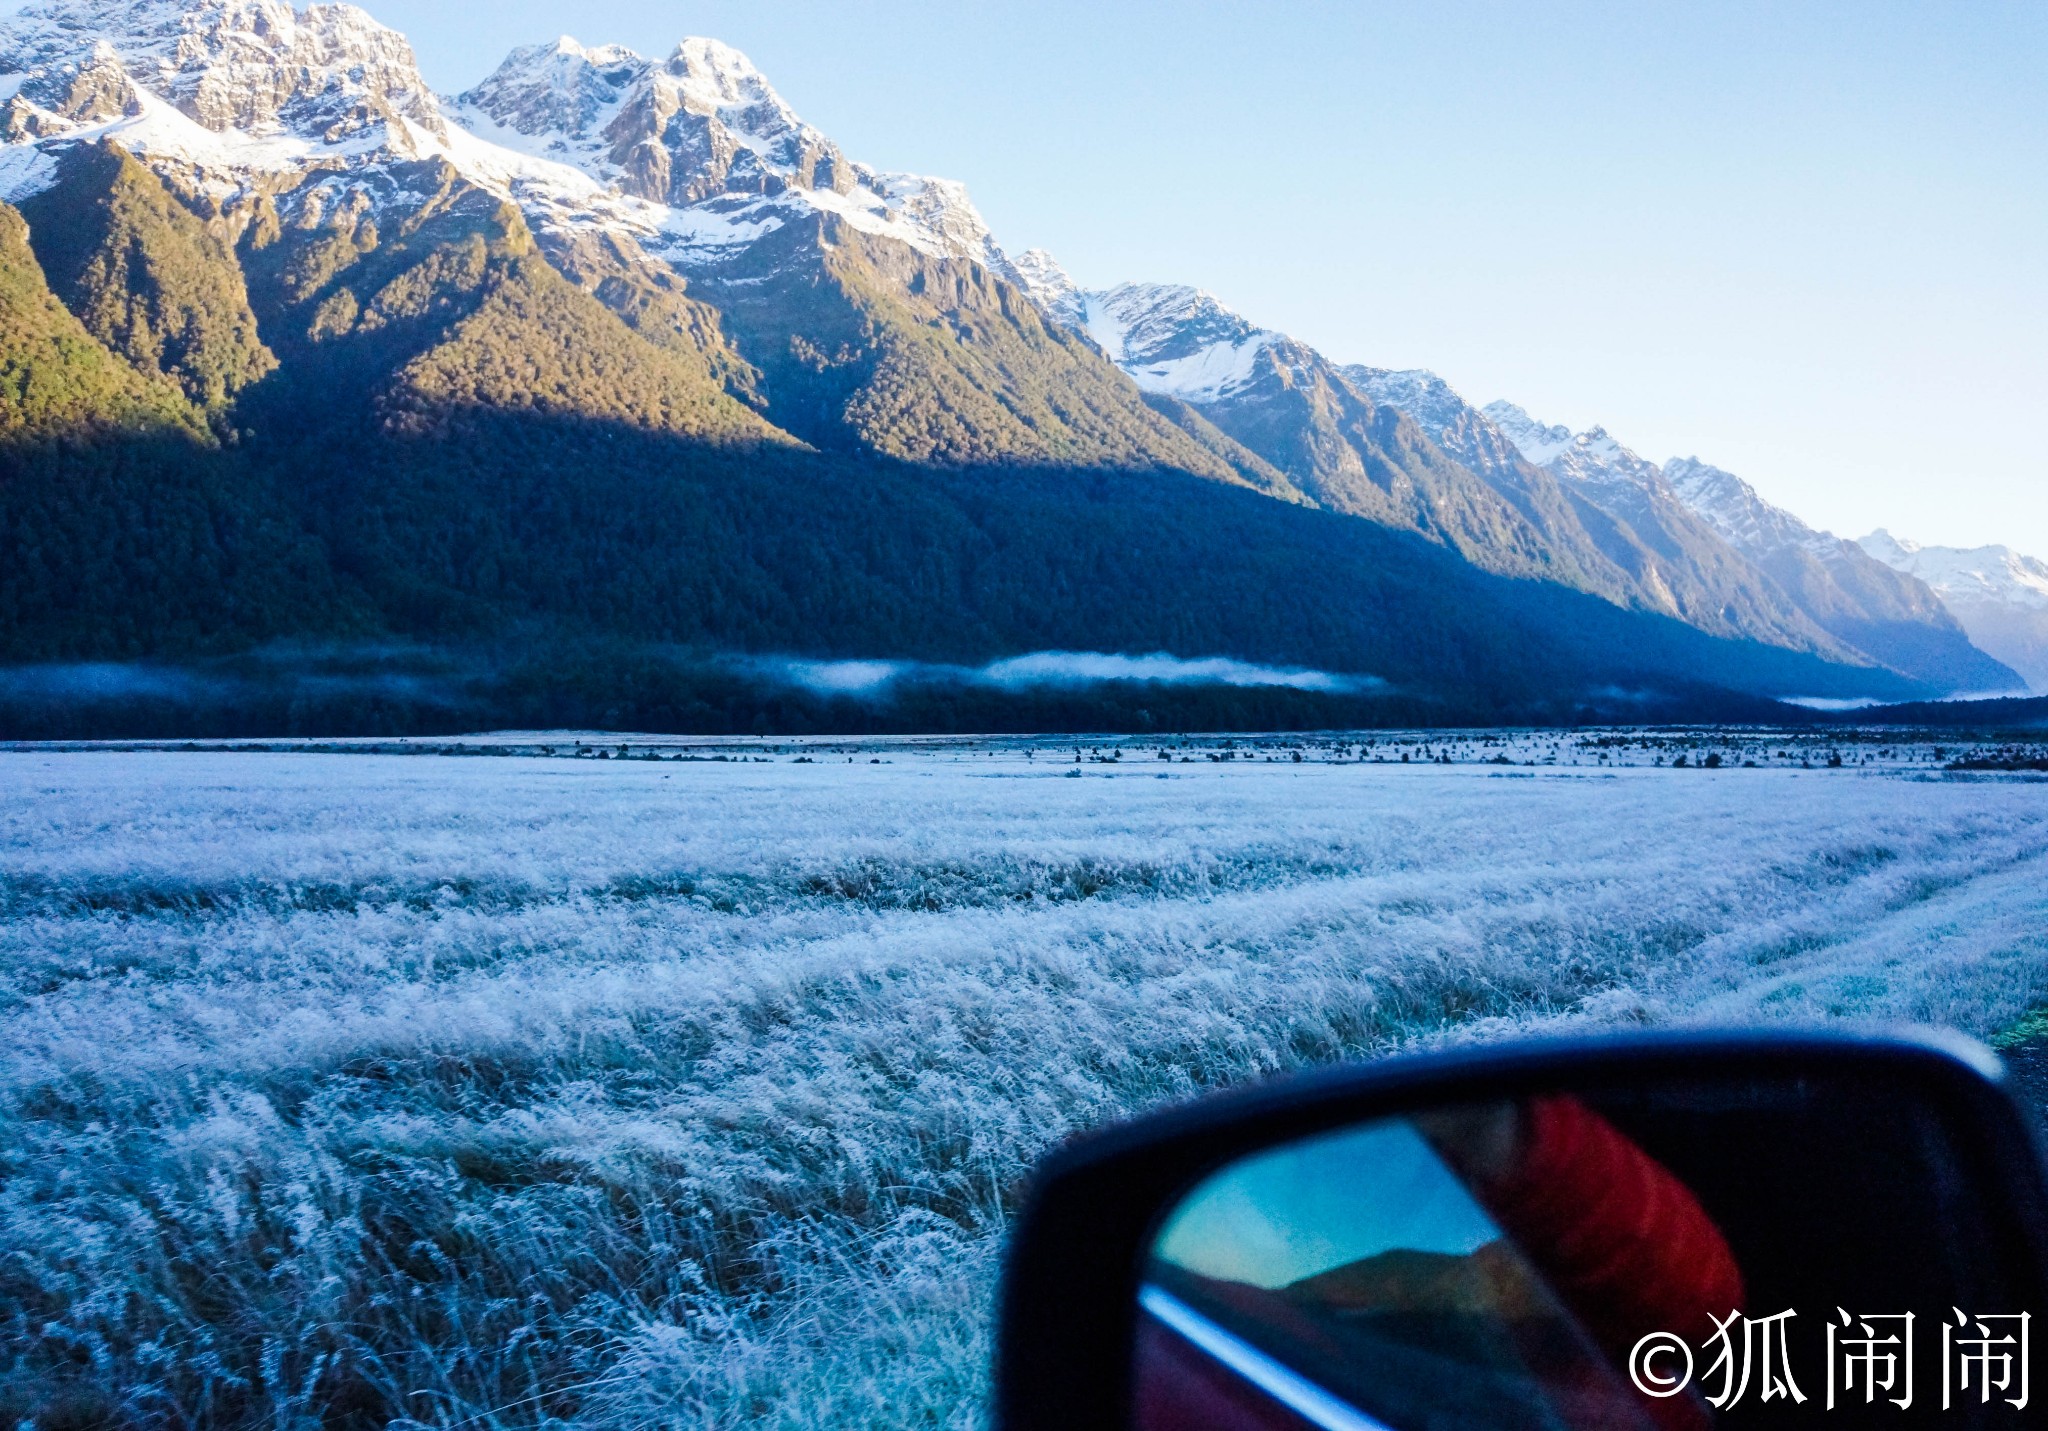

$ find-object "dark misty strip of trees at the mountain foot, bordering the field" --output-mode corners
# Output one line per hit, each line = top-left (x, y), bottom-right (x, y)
(0, 633), (1810, 741)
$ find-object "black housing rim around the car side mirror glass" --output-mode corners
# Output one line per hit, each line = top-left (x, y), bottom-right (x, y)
(993, 1032), (2048, 1431)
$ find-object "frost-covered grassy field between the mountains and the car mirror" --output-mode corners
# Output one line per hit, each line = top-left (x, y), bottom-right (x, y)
(0, 745), (2048, 1427)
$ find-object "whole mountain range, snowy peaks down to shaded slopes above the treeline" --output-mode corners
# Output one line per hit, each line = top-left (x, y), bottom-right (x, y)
(0, 0), (2015, 728)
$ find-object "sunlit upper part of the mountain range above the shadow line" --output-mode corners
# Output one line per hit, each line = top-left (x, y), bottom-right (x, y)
(0, 0), (2015, 712)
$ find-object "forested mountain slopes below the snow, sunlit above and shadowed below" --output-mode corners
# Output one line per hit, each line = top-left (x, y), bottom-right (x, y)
(0, 149), (1923, 735)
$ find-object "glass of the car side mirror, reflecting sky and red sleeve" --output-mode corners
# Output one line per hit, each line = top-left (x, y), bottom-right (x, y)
(1133, 1081), (2036, 1431)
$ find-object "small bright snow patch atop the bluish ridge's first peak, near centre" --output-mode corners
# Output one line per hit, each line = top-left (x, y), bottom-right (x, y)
(1079, 283), (1288, 403)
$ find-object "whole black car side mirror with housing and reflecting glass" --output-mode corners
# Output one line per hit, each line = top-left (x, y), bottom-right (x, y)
(995, 1034), (2048, 1431)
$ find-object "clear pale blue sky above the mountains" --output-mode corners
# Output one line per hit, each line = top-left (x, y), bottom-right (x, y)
(36, 0), (2048, 555)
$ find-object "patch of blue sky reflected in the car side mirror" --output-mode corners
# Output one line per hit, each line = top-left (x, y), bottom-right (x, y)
(1153, 1120), (1501, 1290)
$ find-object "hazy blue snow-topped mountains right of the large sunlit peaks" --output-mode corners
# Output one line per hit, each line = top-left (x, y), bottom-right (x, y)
(1018, 266), (1980, 676)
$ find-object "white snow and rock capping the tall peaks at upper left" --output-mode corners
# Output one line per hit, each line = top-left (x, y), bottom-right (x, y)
(0, 0), (1014, 276)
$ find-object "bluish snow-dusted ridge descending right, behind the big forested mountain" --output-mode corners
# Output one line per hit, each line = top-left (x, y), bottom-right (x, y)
(1018, 252), (2015, 690)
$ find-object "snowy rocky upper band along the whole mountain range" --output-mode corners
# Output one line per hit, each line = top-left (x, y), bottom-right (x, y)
(0, 0), (2038, 696)
